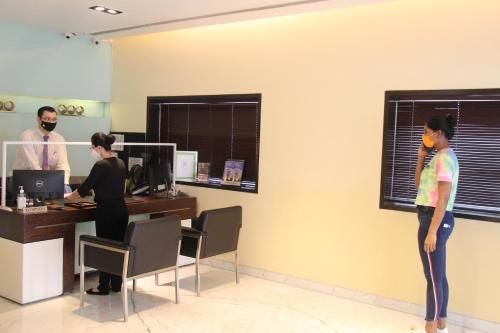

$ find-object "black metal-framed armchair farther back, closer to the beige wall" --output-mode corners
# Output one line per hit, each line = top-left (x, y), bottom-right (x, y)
(180, 206), (242, 296)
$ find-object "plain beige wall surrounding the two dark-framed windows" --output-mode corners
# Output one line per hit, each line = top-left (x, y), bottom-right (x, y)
(112, 0), (500, 322)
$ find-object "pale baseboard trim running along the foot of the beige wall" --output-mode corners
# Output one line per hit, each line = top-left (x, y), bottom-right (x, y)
(202, 258), (500, 333)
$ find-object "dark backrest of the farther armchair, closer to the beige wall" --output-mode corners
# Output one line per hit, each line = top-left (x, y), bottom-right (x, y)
(192, 206), (242, 258)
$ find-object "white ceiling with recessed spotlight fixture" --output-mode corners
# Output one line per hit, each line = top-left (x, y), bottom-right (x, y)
(0, 0), (394, 39)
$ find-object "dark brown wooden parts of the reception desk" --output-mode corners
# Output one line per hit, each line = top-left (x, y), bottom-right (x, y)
(0, 197), (196, 300)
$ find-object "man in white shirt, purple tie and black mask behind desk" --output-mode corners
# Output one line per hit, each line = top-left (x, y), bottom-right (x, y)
(14, 106), (70, 185)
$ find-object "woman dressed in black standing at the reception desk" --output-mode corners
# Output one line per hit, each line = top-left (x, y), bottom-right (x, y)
(67, 132), (128, 295)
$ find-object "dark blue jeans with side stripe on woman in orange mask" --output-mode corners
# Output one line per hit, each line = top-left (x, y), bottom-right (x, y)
(418, 207), (455, 321)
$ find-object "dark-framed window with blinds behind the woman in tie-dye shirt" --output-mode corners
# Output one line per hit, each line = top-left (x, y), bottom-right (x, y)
(380, 89), (500, 222)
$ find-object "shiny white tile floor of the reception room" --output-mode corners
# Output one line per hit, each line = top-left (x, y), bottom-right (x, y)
(0, 266), (486, 333)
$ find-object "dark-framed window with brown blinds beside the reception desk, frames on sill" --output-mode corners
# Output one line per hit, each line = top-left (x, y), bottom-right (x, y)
(146, 94), (261, 193)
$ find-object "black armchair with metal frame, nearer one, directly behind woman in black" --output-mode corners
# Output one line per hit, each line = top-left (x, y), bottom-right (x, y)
(80, 216), (182, 321)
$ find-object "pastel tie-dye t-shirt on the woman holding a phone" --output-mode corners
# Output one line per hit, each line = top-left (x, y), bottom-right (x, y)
(415, 148), (458, 211)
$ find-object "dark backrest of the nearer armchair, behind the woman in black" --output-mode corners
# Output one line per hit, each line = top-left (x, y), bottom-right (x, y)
(124, 216), (182, 276)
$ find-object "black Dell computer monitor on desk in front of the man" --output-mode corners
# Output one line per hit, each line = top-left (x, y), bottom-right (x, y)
(11, 170), (64, 206)
